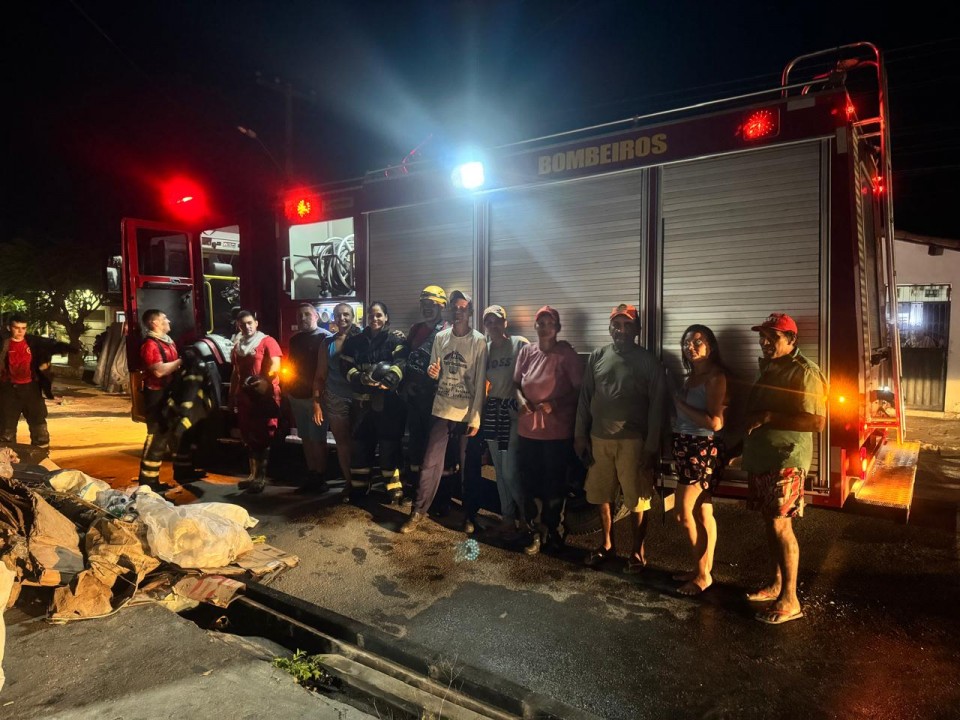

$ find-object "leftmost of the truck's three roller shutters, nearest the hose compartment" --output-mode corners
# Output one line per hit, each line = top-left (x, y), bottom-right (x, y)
(367, 201), (476, 333)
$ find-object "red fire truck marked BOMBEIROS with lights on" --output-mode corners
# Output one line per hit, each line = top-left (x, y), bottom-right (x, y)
(124, 43), (919, 517)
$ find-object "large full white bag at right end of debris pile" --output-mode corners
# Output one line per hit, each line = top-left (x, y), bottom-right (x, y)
(135, 488), (257, 568)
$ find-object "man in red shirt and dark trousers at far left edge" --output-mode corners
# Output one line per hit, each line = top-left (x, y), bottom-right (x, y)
(0, 313), (70, 449)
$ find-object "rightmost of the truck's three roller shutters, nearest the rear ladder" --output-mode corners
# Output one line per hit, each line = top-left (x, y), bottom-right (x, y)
(660, 142), (826, 471)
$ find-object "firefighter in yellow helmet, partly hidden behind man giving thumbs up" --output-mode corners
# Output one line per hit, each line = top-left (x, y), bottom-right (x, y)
(400, 285), (457, 506)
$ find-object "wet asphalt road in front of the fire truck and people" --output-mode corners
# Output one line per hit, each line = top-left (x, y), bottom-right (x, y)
(21, 380), (960, 719)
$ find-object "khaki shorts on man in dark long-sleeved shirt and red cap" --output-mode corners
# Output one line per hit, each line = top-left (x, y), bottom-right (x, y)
(584, 436), (653, 512)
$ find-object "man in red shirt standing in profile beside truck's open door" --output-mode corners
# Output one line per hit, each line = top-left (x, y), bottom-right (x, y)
(138, 309), (183, 490)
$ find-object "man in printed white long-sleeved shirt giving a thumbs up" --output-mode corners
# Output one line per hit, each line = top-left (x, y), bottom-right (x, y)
(400, 290), (487, 533)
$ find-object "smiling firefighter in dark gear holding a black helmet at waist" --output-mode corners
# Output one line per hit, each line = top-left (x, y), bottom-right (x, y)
(340, 302), (407, 502)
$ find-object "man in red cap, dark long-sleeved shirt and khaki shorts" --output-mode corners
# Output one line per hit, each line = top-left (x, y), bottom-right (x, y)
(574, 304), (664, 573)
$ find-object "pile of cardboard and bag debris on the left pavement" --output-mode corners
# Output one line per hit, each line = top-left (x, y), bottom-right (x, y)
(0, 448), (299, 623)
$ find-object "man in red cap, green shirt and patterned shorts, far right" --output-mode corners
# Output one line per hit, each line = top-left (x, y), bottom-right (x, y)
(743, 313), (827, 625)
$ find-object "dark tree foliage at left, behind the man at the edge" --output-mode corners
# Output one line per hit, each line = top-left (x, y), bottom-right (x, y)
(0, 238), (104, 363)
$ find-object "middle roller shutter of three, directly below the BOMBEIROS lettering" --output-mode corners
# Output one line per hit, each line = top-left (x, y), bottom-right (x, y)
(488, 171), (643, 353)
